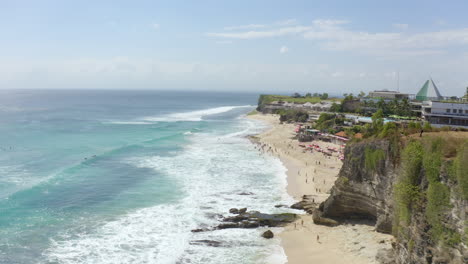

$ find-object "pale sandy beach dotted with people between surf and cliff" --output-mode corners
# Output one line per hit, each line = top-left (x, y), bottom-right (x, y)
(248, 114), (392, 264)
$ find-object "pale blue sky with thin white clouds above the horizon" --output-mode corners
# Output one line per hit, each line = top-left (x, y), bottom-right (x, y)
(0, 0), (468, 96)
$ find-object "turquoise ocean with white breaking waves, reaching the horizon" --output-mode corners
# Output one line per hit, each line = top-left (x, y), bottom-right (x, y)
(0, 90), (292, 264)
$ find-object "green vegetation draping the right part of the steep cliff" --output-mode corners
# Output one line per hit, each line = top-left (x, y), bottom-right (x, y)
(393, 137), (468, 246)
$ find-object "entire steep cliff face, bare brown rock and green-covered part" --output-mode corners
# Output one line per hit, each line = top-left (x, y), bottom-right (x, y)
(320, 139), (468, 264)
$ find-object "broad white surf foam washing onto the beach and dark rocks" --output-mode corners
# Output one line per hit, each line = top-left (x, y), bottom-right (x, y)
(46, 117), (292, 264)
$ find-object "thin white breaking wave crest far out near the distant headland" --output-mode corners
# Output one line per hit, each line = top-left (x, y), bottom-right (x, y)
(142, 105), (253, 122)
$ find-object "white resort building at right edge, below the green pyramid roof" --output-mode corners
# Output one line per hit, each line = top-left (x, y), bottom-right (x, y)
(421, 101), (468, 126)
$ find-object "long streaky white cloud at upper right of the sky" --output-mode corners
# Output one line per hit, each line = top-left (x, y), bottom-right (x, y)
(205, 19), (468, 58)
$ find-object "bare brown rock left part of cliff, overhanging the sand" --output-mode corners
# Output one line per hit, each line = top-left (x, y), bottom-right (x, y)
(321, 141), (396, 233)
